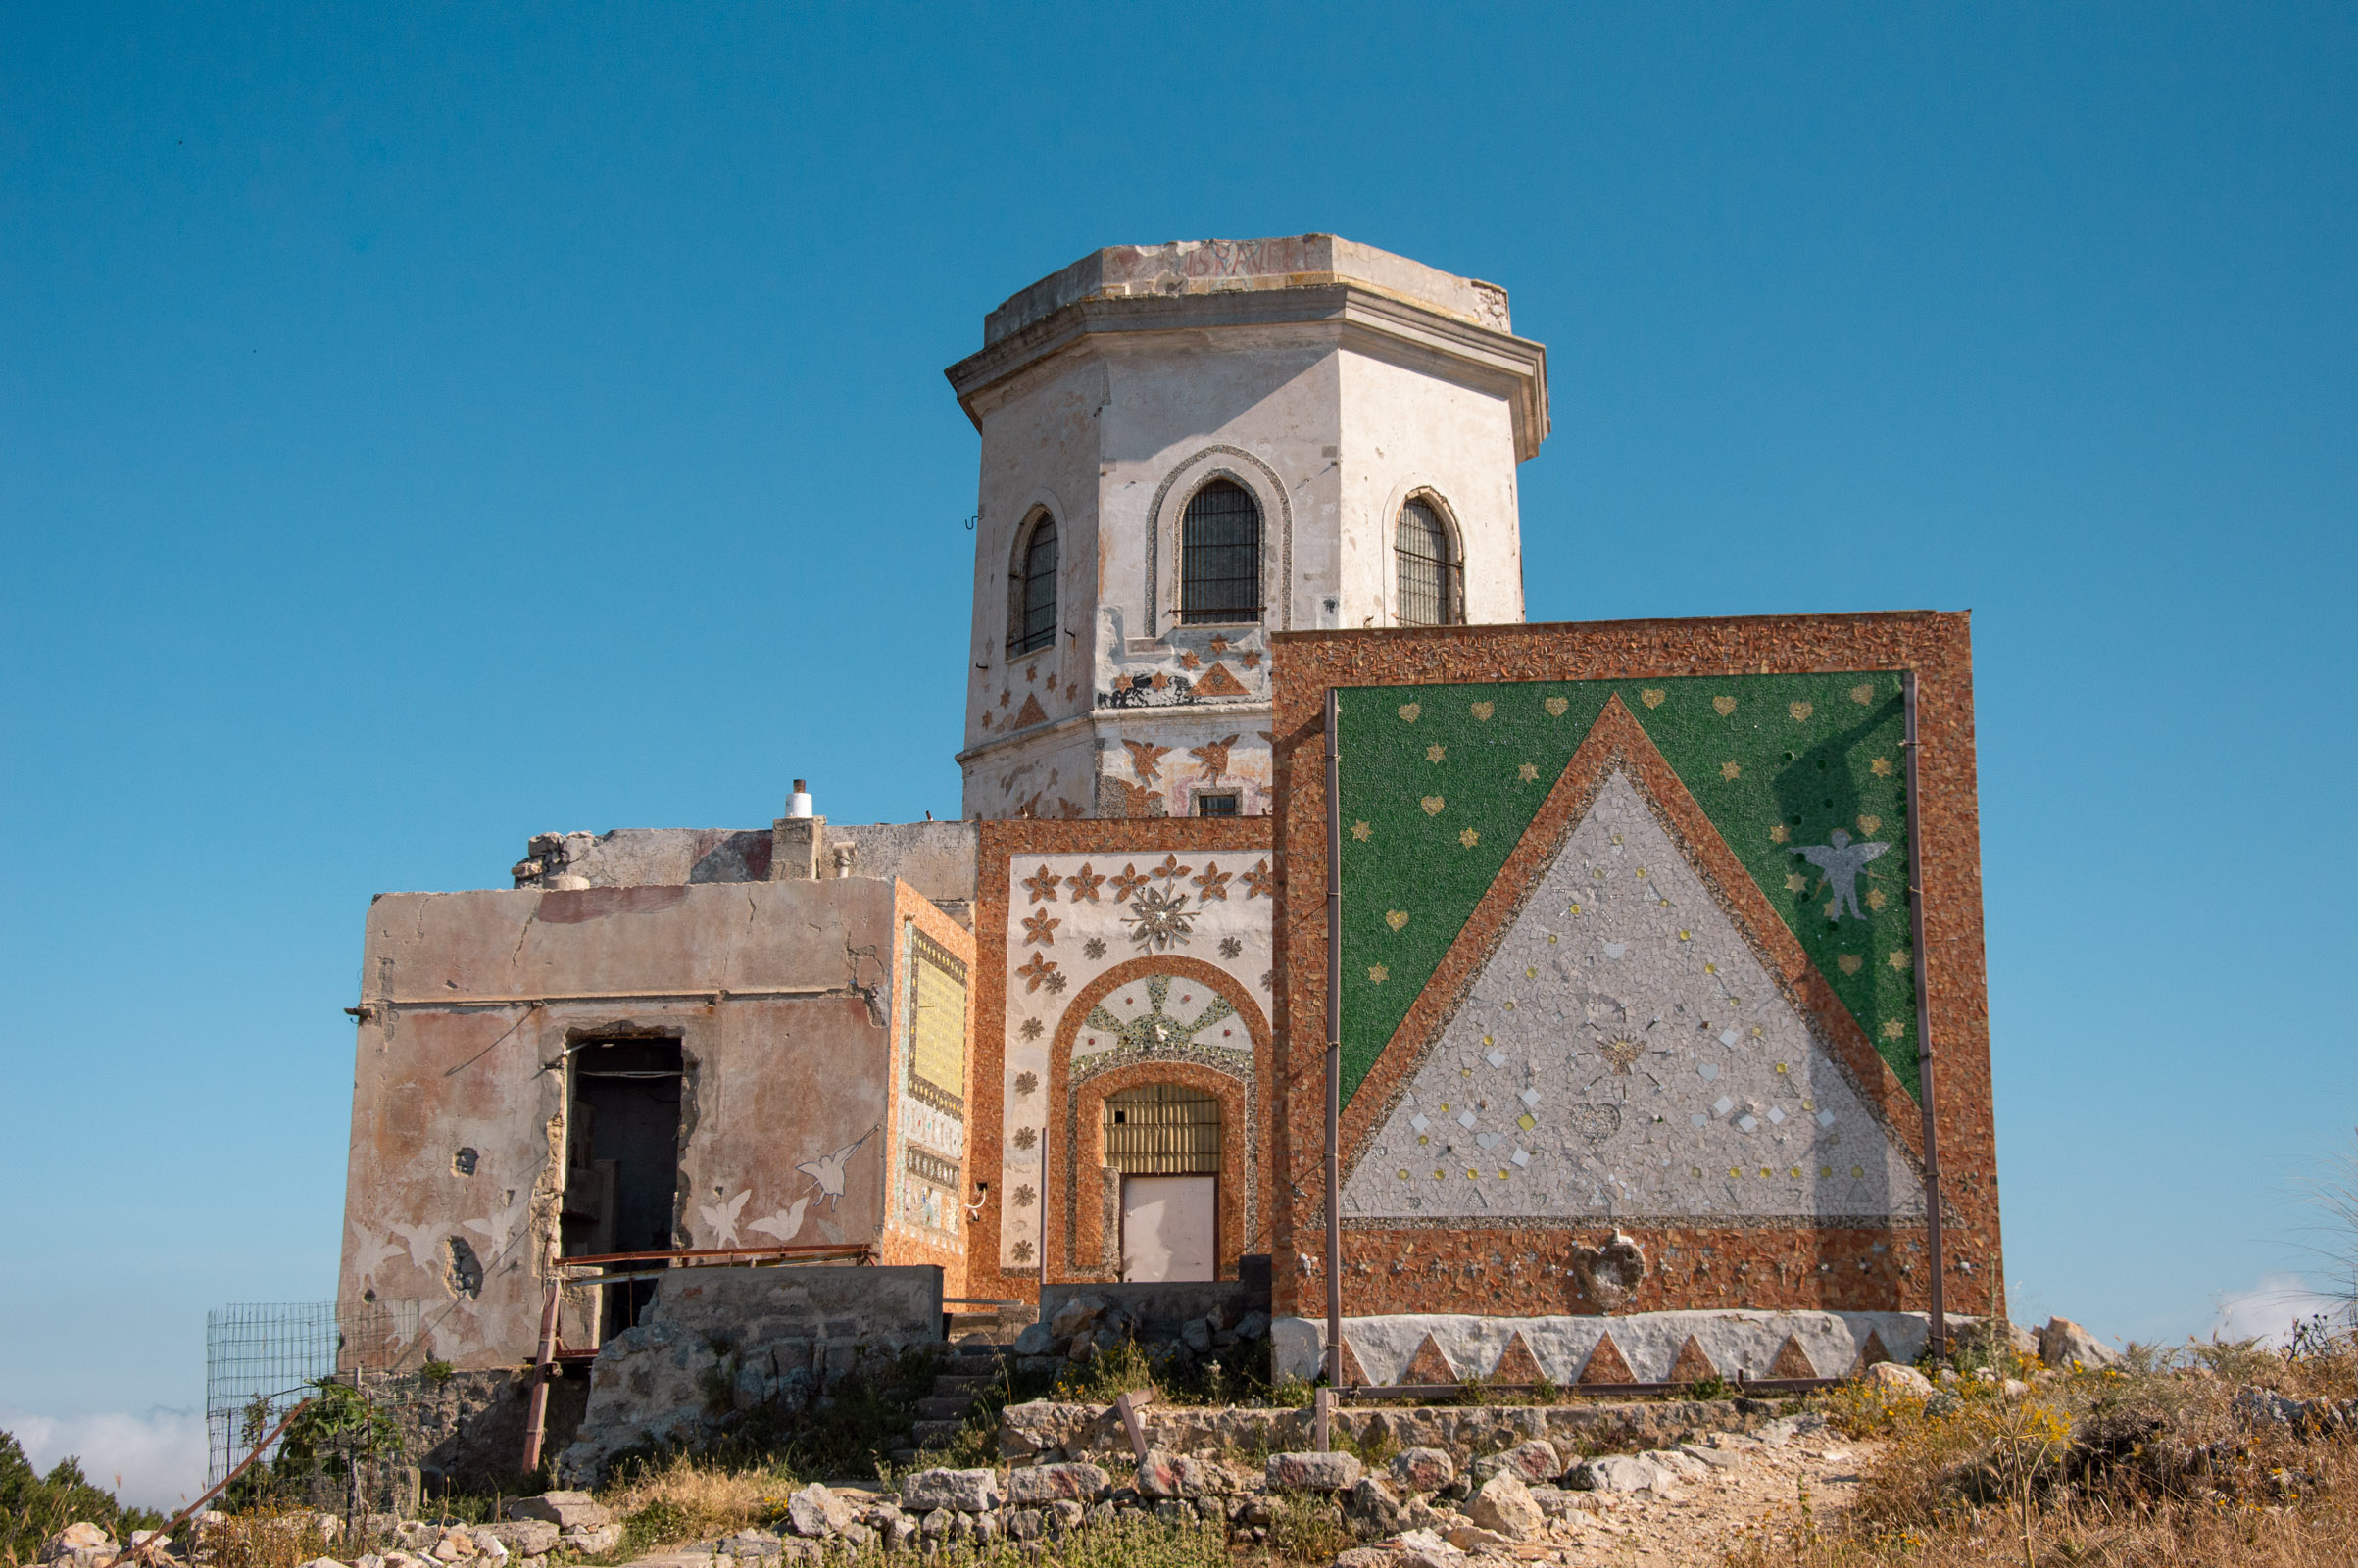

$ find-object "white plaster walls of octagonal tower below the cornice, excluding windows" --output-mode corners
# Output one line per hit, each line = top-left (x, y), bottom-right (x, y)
(964, 306), (1523, 815)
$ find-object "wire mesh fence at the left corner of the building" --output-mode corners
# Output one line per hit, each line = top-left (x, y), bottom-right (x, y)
(205, 1301), (418, 1486)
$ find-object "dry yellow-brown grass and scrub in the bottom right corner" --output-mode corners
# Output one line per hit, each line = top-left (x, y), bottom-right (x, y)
(1729, 1340), (2358, 1568)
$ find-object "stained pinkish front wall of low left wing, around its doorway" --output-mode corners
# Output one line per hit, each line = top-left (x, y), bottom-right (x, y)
(337, 877), (971, 1367)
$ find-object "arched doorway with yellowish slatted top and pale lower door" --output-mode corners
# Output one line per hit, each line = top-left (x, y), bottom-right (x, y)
(1104, 1082), (1221, 1280)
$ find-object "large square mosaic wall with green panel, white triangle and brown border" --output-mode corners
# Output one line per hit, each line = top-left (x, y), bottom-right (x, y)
(1276, 615), (1997, 1313)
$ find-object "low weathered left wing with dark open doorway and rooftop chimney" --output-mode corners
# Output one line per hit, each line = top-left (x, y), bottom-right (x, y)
(337, 818), (974, 1370)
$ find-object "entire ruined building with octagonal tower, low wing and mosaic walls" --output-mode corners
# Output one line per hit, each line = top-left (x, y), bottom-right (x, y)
(339, 236), (2002, 1414)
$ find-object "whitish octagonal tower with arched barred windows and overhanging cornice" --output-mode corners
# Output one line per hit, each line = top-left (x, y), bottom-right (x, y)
(946, 233), (1547, 818)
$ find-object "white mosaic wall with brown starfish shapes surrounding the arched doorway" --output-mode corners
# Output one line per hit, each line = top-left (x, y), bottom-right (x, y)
(969, 815), (1278, 1299)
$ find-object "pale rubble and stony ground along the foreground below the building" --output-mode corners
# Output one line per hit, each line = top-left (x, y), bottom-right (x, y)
(23, 1325), (2159, 1568)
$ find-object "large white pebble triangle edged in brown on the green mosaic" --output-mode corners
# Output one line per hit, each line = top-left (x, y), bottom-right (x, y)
(1344, 768), (1924, 1221)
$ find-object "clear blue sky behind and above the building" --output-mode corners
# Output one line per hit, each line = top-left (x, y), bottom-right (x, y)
(0, 5), (2358, 1497)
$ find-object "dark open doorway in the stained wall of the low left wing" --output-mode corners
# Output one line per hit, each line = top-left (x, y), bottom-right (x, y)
(564, 1040), (681, 1342)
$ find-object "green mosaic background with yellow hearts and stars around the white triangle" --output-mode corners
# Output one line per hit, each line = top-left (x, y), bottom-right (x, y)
(1337, 669), (1917, 1099)
